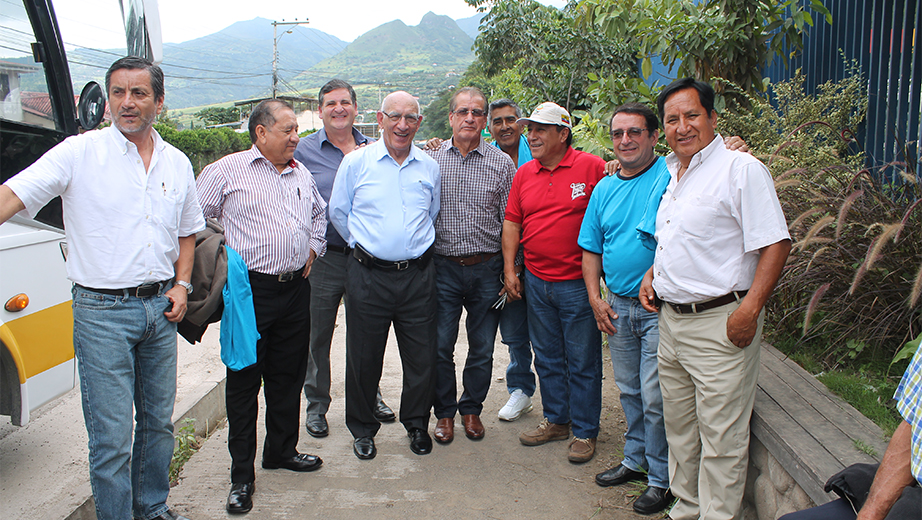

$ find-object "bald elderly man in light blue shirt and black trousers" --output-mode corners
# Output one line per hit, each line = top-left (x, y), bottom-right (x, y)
(330, 91), (440, 459)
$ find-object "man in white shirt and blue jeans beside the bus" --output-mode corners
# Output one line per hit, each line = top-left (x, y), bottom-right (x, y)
(0, 57), (205, 520)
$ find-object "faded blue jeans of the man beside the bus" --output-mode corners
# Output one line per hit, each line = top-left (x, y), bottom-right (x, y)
(72, 286), (176, 520)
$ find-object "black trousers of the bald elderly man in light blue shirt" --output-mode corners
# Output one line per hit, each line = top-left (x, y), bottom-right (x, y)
(346, 256), (438, 438)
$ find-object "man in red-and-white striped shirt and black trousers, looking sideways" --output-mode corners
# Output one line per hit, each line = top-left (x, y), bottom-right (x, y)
(197, 99), (327, 513)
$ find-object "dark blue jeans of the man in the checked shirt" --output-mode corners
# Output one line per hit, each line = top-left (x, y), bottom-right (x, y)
(434, 255), (503, 419)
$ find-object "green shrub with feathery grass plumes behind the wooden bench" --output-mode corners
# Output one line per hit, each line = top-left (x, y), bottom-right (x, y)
(719, 67), (922, 374)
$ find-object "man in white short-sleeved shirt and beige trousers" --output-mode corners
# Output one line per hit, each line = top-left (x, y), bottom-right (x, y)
(640, 78), (791, 520)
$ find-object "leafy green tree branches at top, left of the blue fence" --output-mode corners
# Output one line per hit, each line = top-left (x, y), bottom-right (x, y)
(576, 0), (832, 93)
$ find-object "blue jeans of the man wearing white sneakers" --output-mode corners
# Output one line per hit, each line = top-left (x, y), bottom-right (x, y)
(499, 294), (535, 397)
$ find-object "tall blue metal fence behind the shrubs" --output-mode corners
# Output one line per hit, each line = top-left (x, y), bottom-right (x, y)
(764, 0), (922, 180)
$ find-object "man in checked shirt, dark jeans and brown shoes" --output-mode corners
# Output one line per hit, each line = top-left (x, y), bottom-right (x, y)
(428, 87), (515, 444)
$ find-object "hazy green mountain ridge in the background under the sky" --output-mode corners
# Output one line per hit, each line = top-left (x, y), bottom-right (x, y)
(34, 12), (479, 110)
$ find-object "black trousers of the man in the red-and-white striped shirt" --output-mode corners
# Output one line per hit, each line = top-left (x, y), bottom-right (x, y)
(225, 274), (311, 483)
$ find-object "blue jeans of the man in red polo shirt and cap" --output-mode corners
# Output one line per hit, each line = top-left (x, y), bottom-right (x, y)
(525, 269), (602, 439)
